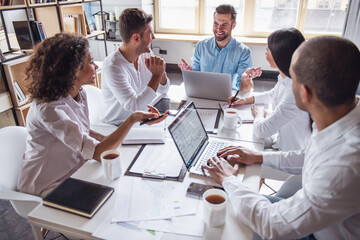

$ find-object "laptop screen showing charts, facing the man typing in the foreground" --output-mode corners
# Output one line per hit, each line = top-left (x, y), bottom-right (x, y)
(168, 103), (208, 168)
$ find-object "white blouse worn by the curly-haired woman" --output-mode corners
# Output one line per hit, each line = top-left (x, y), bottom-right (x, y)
(18, 90), (99, 195)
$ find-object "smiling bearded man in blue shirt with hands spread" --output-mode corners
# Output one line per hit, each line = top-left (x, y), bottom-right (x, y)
(179, 5), (261, 91)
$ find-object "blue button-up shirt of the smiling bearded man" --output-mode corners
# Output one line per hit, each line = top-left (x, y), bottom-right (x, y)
(191, 37), (252, 89)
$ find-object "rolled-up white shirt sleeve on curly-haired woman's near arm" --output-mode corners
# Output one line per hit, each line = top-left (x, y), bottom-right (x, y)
(39, 101), (99, 159)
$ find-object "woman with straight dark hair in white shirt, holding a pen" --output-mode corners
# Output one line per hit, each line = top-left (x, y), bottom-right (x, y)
(228, 28), (311, 151)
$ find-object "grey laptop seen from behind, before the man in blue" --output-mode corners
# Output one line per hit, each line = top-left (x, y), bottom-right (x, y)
(182, 70), (231, 101)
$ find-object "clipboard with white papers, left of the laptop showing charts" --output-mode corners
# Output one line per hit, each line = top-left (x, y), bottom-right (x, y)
(125, 139), (186, 181)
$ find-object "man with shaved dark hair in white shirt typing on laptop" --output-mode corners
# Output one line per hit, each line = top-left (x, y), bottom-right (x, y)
(204, 37), (360, 239)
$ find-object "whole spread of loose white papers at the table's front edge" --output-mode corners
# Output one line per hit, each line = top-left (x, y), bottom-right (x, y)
(97, 176), (204, 240)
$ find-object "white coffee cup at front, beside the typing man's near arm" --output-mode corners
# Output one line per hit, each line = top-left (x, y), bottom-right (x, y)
(203, 188), (228, 227)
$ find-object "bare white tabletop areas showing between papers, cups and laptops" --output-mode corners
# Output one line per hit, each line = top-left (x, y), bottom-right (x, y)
(29, 89), (263, 240)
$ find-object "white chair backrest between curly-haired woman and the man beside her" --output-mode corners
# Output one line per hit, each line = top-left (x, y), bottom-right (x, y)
(82, 85), (102, 123)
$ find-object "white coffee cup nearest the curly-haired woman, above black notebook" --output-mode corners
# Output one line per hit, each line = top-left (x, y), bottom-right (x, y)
(100, 150), (121, 180)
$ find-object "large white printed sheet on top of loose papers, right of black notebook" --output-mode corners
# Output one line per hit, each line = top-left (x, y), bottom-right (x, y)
(111, 176), (198, 222)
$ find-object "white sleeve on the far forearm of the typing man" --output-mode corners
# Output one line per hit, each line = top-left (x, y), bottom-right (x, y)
(262, 149), (305, 175)
